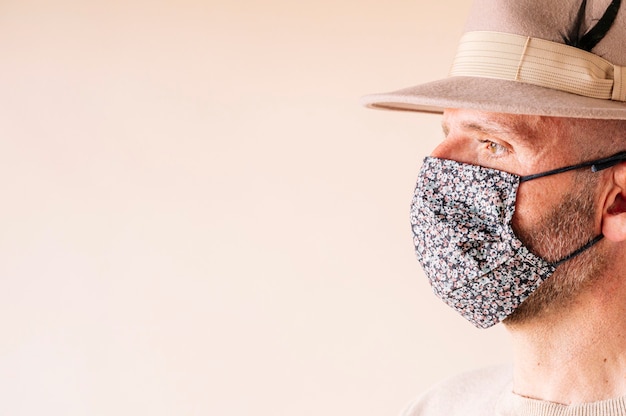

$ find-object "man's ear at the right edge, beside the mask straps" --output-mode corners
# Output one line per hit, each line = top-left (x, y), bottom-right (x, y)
(602, 163), (626, 242)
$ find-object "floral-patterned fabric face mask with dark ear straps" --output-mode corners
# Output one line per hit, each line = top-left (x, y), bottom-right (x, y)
(411, 152), (626, 328)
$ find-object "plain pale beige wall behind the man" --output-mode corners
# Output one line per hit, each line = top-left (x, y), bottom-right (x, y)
(0, 0), (508, 416)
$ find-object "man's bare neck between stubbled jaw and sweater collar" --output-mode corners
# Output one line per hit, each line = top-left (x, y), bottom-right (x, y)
(507, 272), (626, 404)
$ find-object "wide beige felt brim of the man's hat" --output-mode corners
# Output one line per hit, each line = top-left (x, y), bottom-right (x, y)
(361, 77), (626, 120)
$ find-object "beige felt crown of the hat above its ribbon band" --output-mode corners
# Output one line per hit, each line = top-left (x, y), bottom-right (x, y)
(465, 0), (626, 66)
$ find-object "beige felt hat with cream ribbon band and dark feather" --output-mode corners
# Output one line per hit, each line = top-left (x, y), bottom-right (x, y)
(362, 0), (626, 120)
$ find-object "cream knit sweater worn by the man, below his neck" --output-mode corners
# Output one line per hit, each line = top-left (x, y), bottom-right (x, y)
(401, 367), (626, 416)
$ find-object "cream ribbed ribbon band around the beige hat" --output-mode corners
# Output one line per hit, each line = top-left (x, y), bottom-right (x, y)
(450, 32), (626, 101)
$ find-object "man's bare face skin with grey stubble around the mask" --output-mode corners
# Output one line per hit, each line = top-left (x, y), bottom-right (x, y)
(432, 110), (606, 323)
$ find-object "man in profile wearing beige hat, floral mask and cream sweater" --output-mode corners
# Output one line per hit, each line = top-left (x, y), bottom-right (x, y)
(364, 0), (626, 416)
